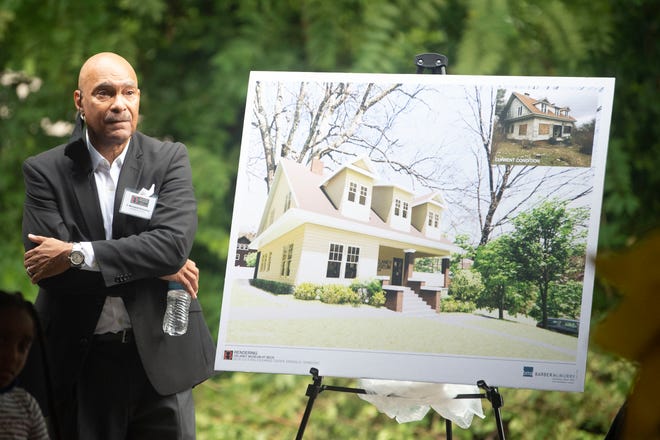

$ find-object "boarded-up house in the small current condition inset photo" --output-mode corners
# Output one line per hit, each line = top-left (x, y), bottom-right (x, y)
(500, 92), (576, 141)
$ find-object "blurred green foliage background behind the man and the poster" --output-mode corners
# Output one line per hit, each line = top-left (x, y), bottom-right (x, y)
(0, 0), (660, 439)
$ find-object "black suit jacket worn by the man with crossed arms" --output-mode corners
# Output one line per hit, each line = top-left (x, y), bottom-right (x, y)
(23, 126), (215, 400)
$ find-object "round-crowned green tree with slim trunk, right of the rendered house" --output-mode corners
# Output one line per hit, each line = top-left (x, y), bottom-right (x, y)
(508, 200), (587, 325)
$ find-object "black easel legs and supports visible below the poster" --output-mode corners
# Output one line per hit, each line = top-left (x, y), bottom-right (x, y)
(296, 368), (505, 440)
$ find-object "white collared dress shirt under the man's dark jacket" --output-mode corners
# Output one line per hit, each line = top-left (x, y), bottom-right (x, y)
(80, 130), (131, 334)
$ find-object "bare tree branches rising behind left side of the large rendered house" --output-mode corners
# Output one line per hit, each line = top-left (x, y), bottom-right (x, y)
(252, 82), (433, 188)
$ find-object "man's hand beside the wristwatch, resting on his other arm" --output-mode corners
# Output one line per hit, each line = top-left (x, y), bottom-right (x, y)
(23, 234), (73, 284)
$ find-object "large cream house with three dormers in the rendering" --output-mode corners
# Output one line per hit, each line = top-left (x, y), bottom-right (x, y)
(250, 158), (456, 300)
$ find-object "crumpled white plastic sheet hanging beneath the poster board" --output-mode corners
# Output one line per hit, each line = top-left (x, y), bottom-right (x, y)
(358, 379), (485, 429)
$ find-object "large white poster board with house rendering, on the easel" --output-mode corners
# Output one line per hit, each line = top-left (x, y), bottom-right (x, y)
(216, 72), (614, 391)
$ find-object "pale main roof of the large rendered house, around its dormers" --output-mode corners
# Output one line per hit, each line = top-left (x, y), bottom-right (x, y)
(257, 159), (455, 249)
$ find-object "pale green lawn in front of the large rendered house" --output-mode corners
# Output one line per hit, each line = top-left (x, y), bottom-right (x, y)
(226, 284), (577, 362)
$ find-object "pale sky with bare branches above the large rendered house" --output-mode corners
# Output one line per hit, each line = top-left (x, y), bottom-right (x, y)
(250, 82), (592, 244)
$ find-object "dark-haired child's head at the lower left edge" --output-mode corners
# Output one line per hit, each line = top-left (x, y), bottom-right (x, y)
(0, 290), (36, 389)
